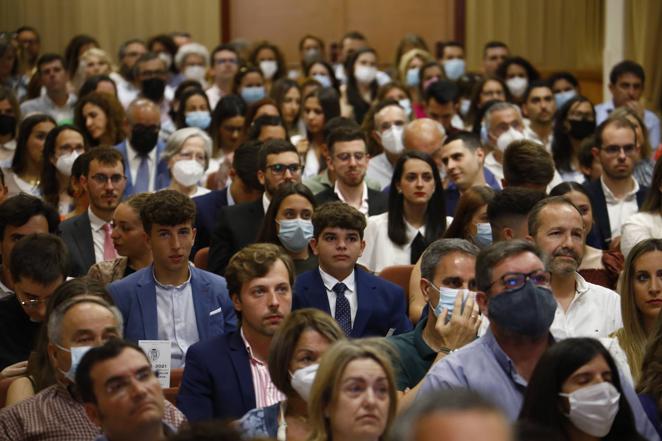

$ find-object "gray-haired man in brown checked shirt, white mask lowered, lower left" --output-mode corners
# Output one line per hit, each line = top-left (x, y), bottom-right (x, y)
(0, 288), (184, 441)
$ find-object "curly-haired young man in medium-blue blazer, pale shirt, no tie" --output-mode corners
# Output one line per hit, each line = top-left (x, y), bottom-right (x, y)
(108, 190), (237, 368)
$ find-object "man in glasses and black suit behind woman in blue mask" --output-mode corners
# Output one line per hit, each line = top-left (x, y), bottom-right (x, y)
(208, 139), (302, 275)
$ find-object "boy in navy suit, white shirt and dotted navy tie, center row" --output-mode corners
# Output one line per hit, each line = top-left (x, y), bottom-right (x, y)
(292, 202), (412, 338)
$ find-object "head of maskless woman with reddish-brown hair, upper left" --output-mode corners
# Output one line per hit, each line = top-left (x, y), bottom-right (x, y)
(74, 92), (125, 147)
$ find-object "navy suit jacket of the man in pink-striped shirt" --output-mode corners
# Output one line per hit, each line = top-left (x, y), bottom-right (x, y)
(177, 331), (256, 421)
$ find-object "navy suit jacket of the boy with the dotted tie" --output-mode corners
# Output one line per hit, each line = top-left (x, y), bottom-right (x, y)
(292, 268), (412, 338)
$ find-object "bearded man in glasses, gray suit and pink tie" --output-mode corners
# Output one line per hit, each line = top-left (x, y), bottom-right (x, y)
(60, 147), (126, 277)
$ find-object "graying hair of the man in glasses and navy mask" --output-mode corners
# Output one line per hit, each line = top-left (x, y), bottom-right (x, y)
(476, 239), (547, 293)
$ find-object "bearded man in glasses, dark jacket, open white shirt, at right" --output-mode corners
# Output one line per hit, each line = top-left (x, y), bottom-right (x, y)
(586, 118), (648, 250)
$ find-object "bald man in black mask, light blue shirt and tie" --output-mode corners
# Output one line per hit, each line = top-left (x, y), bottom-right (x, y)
(115, 98), (170, 196)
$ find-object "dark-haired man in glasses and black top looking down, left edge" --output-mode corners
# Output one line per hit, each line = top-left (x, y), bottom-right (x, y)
(0, 233), (68, 370)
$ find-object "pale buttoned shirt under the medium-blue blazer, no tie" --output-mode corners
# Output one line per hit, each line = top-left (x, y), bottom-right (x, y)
(152, 267), (200, 368)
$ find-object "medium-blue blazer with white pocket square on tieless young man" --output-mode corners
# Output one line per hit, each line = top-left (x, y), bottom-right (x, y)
(108, 265), (237, 342)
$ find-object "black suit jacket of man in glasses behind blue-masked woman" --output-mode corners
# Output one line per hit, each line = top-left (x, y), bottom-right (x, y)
(208, 197), (264, 275)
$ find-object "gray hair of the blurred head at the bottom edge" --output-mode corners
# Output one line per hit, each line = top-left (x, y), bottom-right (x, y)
(386, 389), (512, 441)
